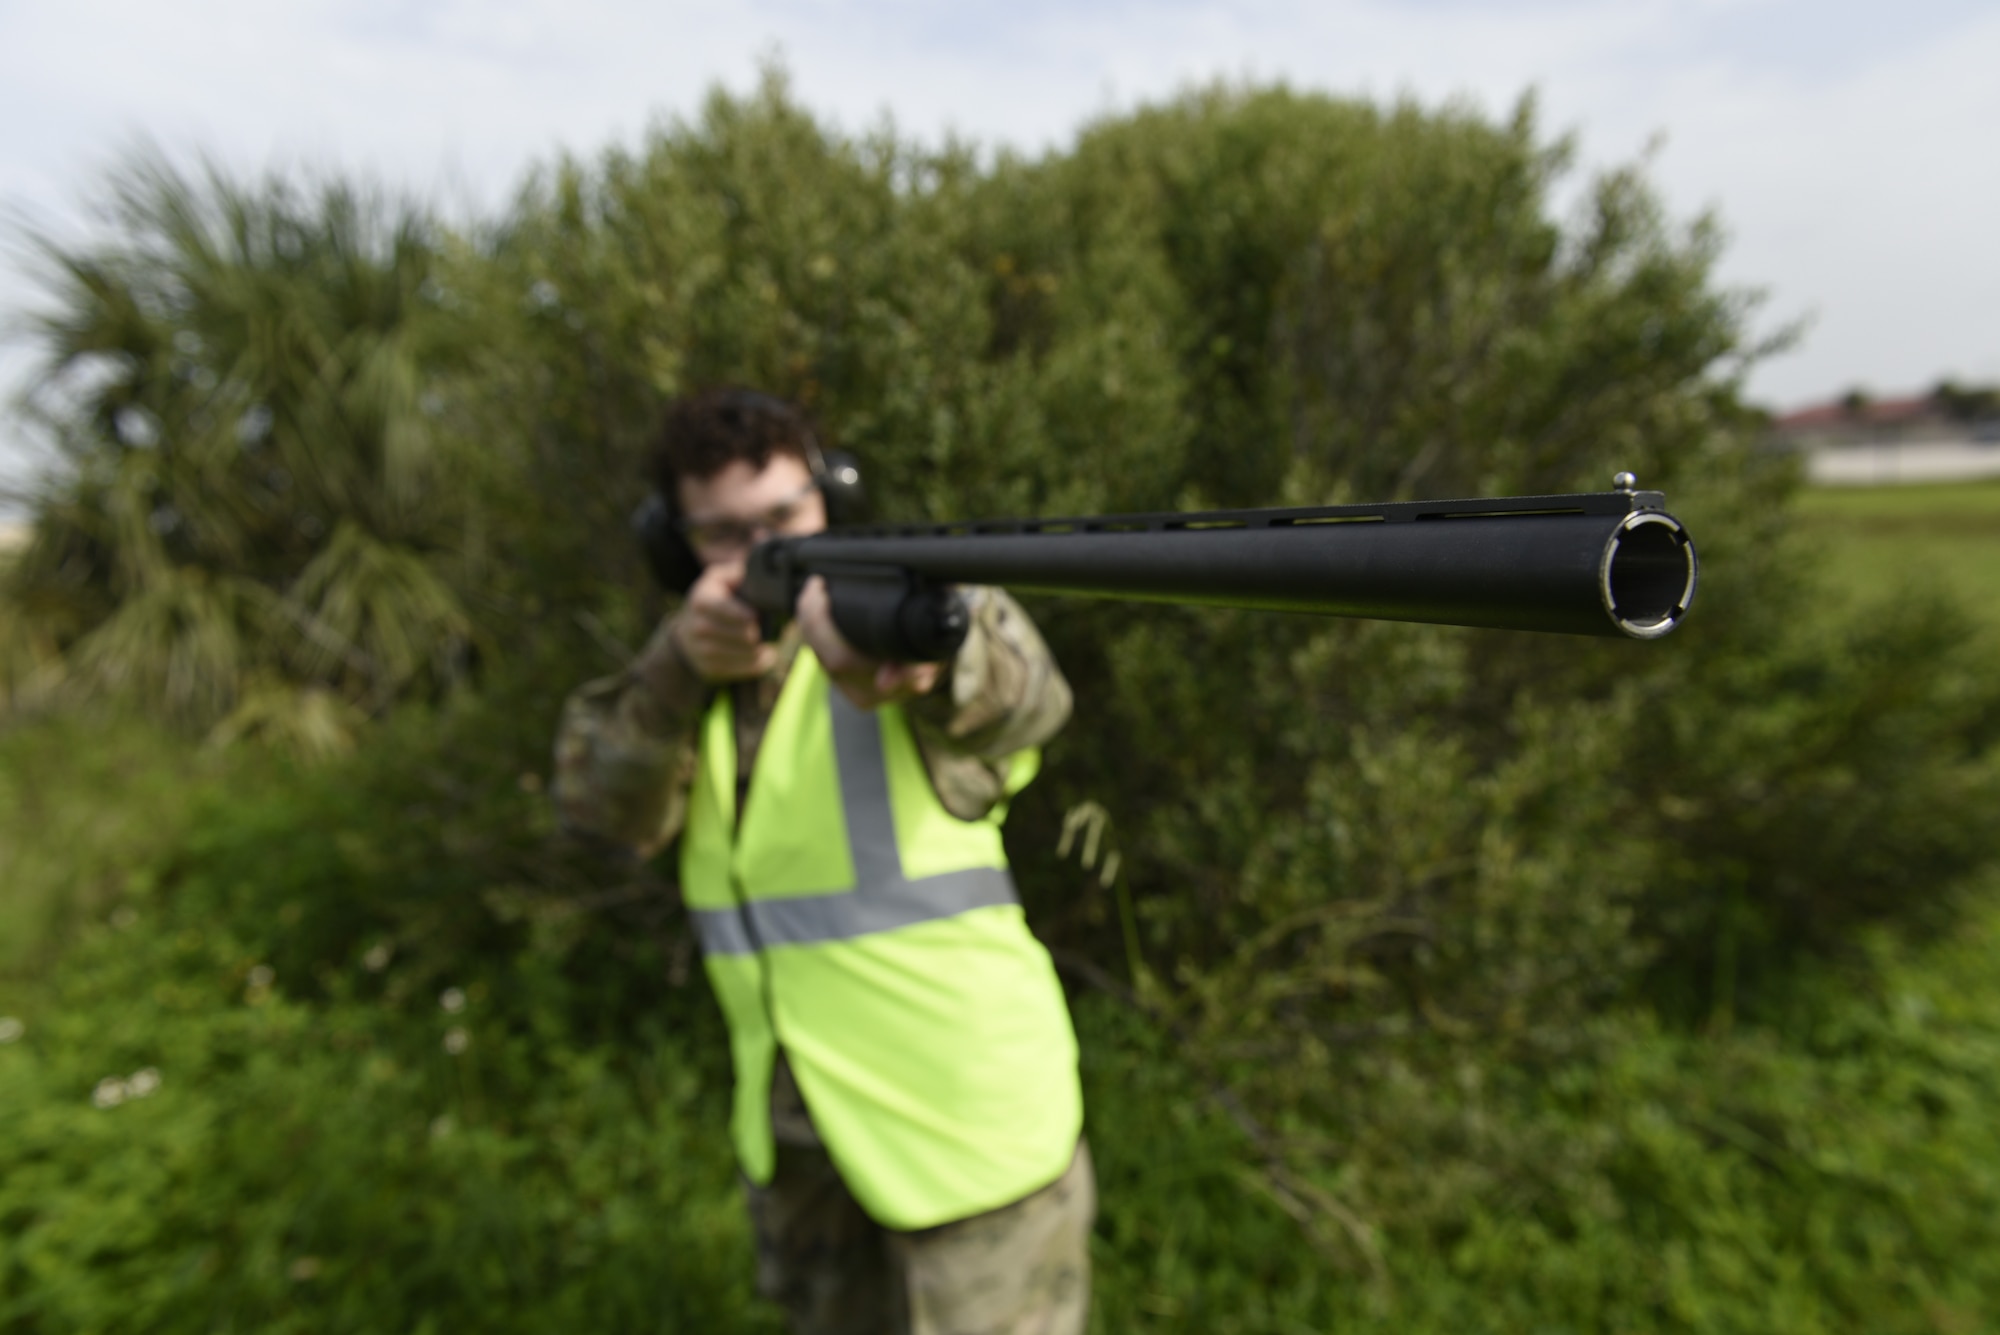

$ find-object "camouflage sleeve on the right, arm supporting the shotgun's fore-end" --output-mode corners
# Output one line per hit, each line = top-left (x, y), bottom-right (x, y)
(908, 588), (1070, 819)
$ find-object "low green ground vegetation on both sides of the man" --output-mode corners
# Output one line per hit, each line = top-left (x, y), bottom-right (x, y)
(0, 699), (2000, 1331)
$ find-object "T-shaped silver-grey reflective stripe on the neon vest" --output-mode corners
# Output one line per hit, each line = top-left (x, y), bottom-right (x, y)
(694, 685), (1018, 955)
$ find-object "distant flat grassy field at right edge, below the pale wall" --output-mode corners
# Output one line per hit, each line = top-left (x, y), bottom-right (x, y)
(1800, 482), (2000, 624)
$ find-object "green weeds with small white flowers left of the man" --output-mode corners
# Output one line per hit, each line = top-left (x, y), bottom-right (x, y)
(0, 695), (774, 1331)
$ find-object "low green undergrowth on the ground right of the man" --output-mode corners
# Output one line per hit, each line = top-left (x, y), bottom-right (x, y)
(1080, 887), (2000, 1335)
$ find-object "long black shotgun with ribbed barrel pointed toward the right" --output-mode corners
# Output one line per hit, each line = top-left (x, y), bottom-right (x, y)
(738, 474), (1696, 662)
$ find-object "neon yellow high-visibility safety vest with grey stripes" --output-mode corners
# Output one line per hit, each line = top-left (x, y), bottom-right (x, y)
(680, 650), (1084, 1229)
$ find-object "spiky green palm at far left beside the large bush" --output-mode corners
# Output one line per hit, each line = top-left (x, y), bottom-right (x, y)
(8, 152), (472, 745)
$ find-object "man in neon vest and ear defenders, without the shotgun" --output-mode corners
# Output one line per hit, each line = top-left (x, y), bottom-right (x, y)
(554, 390), (1096, 1335)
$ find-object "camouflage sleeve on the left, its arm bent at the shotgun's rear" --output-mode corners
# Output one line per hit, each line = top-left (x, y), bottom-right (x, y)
(552, 622), (708, 857)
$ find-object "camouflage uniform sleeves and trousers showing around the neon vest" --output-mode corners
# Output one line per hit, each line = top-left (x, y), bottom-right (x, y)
(554, 588), (1096, 1335)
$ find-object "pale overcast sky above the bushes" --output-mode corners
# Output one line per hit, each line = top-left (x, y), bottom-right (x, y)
(0, 0), (2000, 495)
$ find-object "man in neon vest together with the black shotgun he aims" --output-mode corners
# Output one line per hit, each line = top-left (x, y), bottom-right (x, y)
(556, 390), (1696, 1333)
